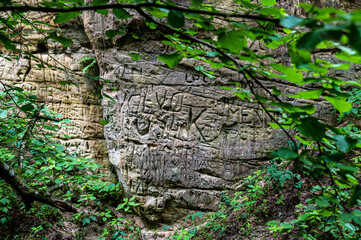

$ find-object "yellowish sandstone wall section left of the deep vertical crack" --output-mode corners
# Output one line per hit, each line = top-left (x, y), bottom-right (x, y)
(0, 10), (109, 172)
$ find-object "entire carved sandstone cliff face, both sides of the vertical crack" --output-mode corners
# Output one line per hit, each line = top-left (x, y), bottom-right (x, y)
(0, 0), (358, 222)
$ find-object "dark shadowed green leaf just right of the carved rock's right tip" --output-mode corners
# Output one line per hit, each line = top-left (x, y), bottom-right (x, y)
(297, 117), (326, 141)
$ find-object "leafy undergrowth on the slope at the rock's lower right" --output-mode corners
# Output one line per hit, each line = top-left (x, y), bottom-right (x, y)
(196, 87), (361, 240)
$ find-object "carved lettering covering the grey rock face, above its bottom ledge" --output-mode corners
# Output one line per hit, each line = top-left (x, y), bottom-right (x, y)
(103, 55), (290, 207)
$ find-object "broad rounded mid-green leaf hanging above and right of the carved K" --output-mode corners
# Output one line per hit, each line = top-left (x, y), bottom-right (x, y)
(218, 31), (248, 53)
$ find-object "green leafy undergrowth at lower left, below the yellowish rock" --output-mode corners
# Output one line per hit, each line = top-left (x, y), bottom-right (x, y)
(0, 88), (140, 239)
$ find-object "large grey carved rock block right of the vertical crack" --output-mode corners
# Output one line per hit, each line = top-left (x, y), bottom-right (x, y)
(83, 1), (335, 223)
